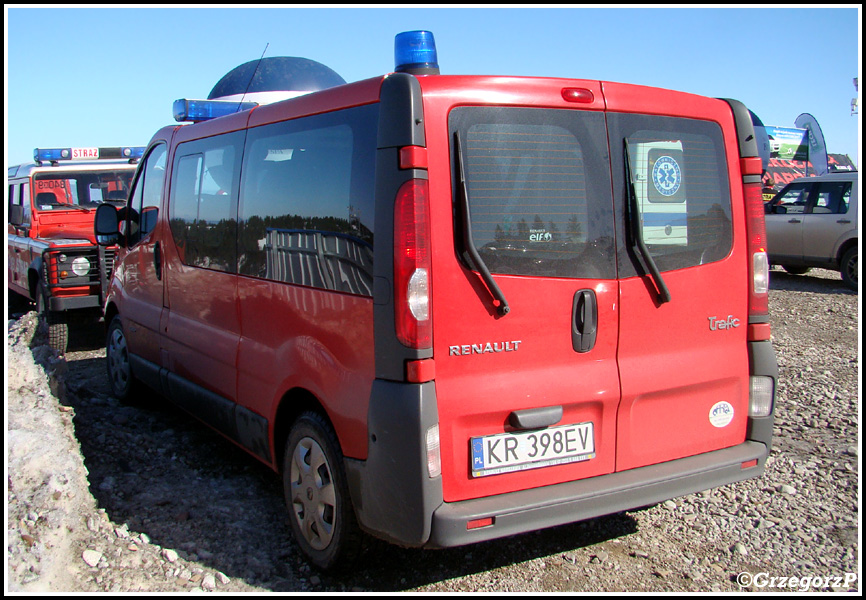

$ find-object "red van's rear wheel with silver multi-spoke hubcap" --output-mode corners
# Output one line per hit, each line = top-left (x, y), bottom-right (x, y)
(283, 412), (363, 571)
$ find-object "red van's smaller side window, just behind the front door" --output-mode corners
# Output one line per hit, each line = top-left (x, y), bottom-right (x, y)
(169, 132), (244, 273)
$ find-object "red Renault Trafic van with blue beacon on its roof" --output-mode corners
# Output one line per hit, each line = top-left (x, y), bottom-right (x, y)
(96, 32), (778, 568)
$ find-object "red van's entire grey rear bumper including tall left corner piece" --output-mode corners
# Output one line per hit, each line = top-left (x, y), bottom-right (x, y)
(344, 380), (775, 548)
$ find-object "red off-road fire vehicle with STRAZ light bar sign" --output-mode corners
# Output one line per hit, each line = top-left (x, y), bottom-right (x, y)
(7, 147), (144, 352)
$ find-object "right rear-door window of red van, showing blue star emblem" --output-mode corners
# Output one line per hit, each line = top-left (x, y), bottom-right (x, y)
(608, 113), (733, 276)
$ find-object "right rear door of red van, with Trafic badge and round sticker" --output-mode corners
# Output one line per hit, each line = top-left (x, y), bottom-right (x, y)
(604, 83), (749, 471)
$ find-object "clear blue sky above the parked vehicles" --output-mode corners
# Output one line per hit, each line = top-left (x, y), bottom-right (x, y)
(5, 5), (861, 165)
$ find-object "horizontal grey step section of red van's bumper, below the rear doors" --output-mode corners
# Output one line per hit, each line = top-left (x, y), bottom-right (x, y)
(425, 441), (769, 548)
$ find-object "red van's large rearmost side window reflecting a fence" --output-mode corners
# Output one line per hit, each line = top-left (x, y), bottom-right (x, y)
(238, 105), (377, 296)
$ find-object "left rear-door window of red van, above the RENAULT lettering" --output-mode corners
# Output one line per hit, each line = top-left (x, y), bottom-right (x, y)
(450, 107), (616, 279)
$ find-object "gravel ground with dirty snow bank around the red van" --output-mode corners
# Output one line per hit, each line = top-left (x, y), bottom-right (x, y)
(6, 270), (860, 593)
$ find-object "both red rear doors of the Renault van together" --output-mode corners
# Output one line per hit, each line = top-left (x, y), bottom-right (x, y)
(422, 77), (749, 501)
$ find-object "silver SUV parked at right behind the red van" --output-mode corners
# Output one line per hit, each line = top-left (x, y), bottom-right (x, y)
(765, 172), (859, 290)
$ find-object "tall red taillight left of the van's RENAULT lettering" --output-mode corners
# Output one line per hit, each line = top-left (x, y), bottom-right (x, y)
(394, 179), (433, 349)
